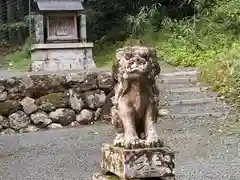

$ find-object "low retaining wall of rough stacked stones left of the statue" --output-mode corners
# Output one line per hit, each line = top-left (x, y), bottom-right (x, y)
(0, 71), (115, 134)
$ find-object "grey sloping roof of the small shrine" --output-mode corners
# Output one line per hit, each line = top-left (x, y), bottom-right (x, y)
(36, 0), (84, 11)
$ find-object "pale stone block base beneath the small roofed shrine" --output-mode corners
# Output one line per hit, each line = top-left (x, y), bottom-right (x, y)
(31, 43), (96, 72)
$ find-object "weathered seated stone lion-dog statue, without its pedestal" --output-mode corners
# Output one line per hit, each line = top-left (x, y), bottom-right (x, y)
(111, 46), (163, 148)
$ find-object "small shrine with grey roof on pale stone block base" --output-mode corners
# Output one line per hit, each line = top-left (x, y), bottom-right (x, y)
(31, 0), (95, 71)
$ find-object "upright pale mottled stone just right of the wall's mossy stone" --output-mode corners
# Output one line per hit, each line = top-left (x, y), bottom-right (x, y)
(69, 89), (84, 112)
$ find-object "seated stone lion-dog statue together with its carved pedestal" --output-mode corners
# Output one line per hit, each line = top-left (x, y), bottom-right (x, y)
(93, 46), (175, 180)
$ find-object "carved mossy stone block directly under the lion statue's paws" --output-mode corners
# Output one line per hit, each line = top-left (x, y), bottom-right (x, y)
(101, 144), (175, 179)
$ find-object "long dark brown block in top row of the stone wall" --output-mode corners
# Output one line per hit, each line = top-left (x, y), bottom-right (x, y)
(21, 74), (66, 98)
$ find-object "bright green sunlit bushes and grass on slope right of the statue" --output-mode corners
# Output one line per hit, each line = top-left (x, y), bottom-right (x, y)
(141, 0), (240, 107)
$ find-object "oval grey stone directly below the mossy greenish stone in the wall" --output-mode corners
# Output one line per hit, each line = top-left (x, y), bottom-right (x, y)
(49, 108), (76, 126)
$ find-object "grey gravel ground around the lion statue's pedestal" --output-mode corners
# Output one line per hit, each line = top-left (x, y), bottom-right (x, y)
(0, 64), (240, 180)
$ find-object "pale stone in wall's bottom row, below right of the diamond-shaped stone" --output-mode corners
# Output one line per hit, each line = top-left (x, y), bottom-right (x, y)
(30, 111), (52, 128)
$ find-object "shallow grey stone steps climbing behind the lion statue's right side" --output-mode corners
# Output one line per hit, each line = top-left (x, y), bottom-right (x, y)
(157, 70), (228, 121)
